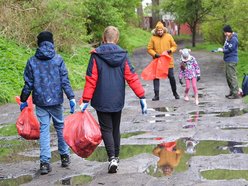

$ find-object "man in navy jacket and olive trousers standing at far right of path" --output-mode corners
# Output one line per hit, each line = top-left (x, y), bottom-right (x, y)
(218, 25), (241, 99)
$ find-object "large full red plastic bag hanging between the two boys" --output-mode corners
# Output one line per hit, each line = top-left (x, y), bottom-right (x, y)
(63, 110), (102, 158)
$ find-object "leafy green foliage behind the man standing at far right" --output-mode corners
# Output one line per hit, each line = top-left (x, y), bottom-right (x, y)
(202, 0), (248, 50)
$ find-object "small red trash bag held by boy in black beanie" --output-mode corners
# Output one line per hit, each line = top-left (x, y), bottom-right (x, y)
(16, 96), (40, 140)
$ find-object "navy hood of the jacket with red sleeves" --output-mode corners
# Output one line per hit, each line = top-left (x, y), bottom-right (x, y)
(93, 43), (127, 67)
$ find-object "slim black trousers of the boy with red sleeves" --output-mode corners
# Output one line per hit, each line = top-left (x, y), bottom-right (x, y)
(97, 111), (121, 159)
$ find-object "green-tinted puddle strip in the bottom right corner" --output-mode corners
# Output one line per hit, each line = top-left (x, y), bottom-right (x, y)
(201, 169), (248, 180)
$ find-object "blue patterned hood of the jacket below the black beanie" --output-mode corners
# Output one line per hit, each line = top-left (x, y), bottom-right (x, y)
(35, 41), (55, 60)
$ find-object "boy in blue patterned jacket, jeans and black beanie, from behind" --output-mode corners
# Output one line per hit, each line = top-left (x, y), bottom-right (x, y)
(20, 31), (76, 174)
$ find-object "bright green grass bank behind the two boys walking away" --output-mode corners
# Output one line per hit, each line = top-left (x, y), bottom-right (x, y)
(0, 27), (151, 104)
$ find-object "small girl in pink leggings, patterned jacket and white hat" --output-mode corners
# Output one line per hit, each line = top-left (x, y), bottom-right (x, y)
(179, 48), (201, 105)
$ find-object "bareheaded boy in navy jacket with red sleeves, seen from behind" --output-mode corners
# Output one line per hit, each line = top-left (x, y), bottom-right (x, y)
(80, 26), (147, 173)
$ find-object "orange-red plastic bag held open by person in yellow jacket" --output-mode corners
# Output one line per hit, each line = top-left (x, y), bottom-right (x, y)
(141, 52), (171, 80)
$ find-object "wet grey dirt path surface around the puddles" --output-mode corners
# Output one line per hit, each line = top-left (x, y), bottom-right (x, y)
(0, 45), (248, 186)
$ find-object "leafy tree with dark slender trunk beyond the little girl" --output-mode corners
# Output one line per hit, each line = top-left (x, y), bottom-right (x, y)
(162, 0), (219, 47)
